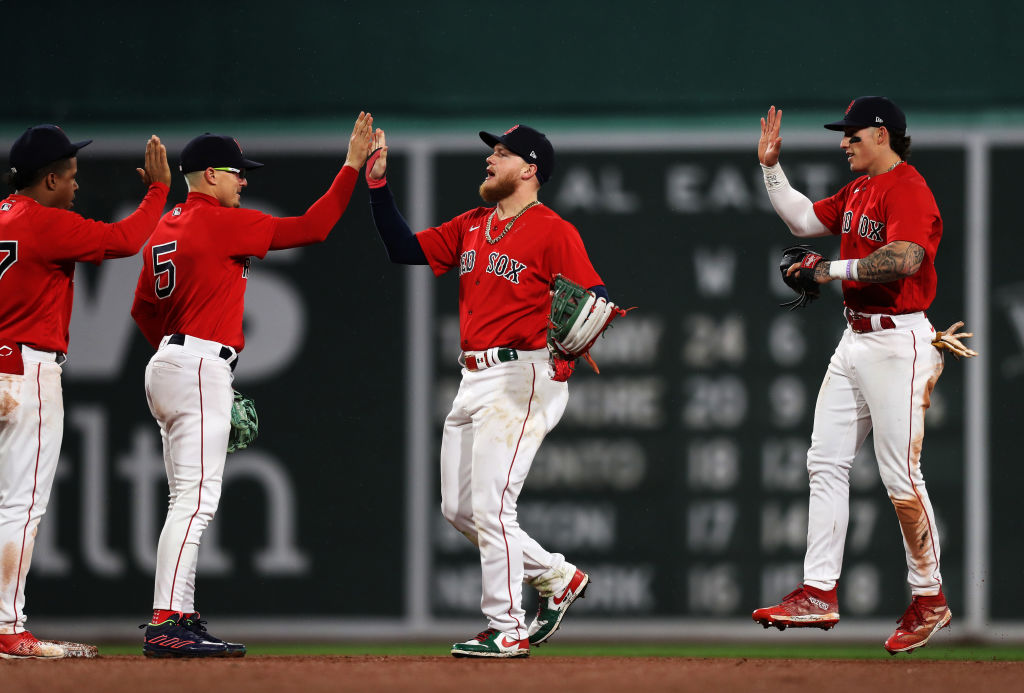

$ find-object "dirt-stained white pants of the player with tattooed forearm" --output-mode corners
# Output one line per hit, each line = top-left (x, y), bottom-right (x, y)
(804, 312), (943, 596)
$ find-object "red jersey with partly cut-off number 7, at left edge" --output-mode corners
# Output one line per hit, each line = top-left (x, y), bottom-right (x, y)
(0, 183), (169, 352)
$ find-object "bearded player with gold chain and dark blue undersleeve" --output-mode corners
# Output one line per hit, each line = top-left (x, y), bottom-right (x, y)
(367, 125), (607, 657)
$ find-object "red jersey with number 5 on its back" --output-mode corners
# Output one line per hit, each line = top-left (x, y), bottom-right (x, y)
(131, 165), (358, 351)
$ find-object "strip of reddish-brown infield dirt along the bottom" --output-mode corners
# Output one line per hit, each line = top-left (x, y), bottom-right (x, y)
(0, 656), (1024, 693)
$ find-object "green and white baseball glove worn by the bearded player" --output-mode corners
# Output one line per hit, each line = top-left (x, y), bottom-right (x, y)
(548, 274), (632, 380)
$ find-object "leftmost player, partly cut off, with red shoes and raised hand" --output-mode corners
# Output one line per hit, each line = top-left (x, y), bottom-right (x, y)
(0, 125), (171, 659)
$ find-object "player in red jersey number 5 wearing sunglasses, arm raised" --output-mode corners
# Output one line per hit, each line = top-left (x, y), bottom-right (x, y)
(132, 113), (373, 657)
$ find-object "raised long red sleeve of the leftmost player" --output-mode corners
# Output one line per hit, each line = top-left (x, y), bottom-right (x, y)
(41, 183), (170, 265)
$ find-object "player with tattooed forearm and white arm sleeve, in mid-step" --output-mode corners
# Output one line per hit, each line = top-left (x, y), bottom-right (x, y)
(753, 96), (958, 654)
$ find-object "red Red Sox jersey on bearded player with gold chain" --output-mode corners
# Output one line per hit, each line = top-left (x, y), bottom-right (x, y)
(416, 205), (602, 351)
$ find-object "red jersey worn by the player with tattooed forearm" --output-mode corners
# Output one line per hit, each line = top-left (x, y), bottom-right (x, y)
(814, 164), (942, 315)
